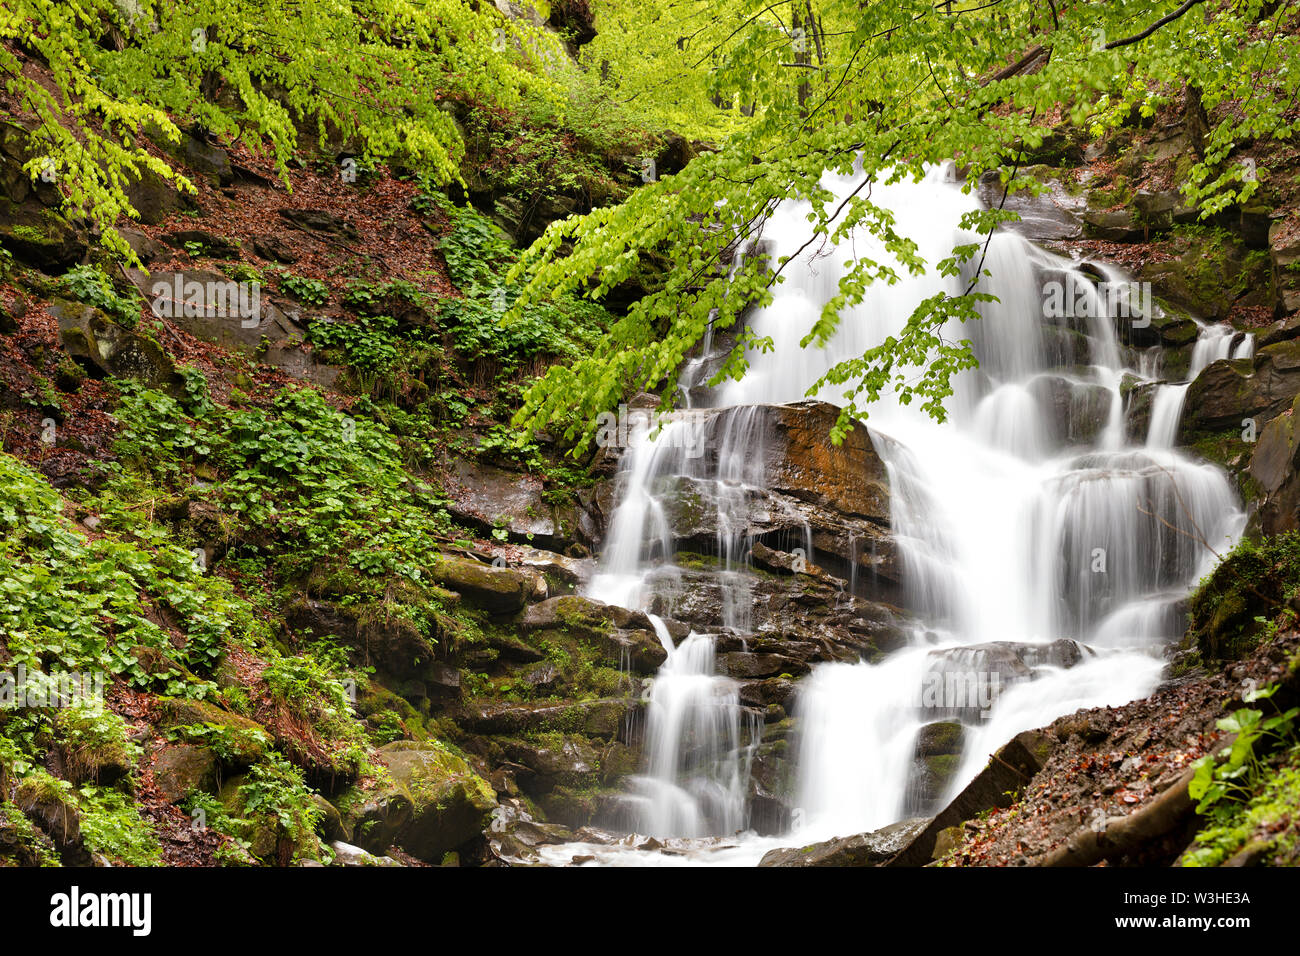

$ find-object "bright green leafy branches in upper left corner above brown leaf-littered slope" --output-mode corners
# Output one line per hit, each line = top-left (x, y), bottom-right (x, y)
(0, 0), (563, 260)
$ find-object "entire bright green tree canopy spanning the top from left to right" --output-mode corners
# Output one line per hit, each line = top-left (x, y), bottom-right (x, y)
(0, 0), (1297, 446)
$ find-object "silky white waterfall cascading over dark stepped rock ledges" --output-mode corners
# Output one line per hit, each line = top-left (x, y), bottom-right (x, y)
(574, 166), (1251, 862)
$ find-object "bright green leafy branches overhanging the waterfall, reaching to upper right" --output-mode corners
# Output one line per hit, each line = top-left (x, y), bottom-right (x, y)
(511, 0), (1300, 441)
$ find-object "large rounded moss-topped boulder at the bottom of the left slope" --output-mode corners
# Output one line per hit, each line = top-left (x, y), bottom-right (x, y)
(378, 740), (497, 862)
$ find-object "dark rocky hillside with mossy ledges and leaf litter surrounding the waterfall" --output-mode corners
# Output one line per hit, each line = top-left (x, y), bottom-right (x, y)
(0, 61), (1300, 865)
